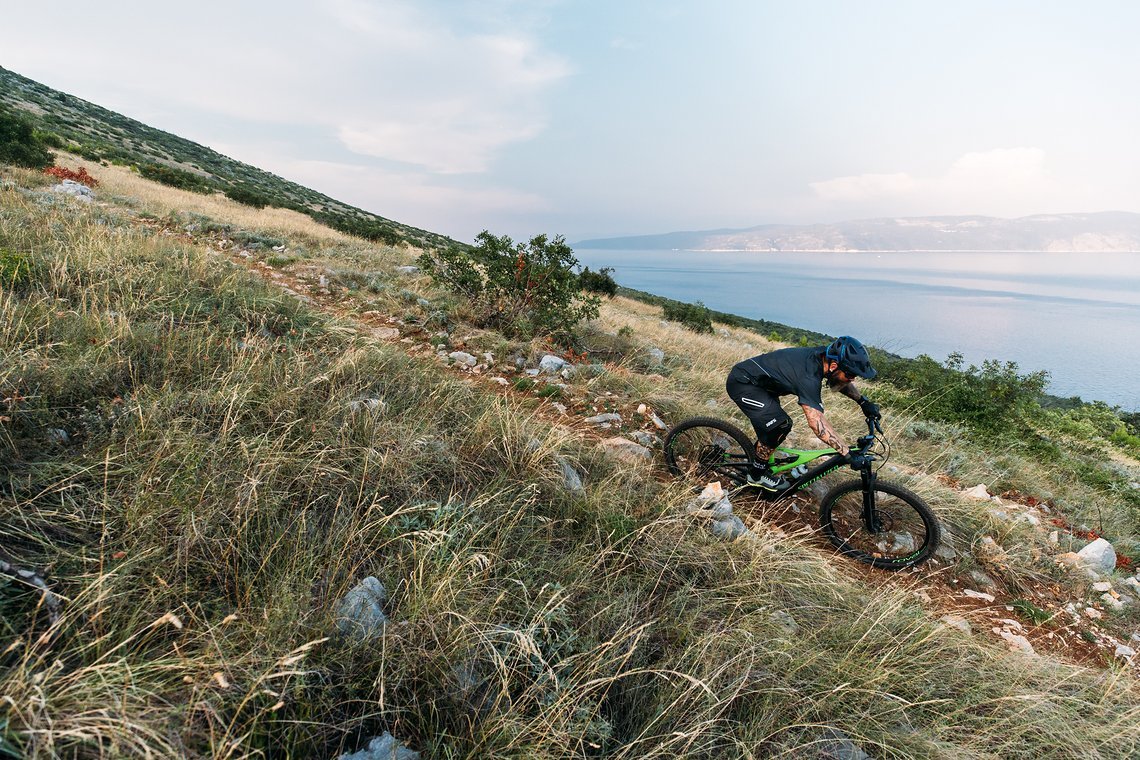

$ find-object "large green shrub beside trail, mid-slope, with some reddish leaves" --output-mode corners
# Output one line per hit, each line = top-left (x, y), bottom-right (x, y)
(418, 230), (600, 337)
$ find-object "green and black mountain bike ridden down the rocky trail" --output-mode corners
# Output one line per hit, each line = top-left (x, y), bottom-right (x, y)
(663, 417), (942, 570)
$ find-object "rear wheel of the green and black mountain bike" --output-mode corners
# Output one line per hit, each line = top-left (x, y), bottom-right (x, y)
(662, 417), (755, 487)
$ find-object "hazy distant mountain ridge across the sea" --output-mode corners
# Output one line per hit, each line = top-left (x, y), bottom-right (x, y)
(573, 211), (1140, 252)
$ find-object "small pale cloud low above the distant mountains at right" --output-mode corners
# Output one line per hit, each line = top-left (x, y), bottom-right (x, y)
(811, 147), (1062, 214)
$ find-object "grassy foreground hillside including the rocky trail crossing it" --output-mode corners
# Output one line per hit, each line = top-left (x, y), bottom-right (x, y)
(0, 96), (1140, 759)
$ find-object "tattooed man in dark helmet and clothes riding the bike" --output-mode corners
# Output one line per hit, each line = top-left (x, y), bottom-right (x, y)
(725, 335), (880, 491)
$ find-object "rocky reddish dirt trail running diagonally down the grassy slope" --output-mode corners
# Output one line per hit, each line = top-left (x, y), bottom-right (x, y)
(120, 201), (1140, 675)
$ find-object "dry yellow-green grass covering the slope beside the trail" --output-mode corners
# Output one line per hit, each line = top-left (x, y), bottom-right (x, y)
(0, 169), (1140, 758)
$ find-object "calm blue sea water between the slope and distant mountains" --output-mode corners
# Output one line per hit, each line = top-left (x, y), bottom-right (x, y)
(575, 248), (1140, 410)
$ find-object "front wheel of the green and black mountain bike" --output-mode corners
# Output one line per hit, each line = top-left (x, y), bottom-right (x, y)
(820, 480), (942, 570)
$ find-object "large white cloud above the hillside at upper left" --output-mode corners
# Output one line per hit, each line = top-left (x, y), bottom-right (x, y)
(5, 0), (571, 173)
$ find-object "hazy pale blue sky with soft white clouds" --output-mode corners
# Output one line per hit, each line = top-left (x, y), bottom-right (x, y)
(0, 0), (1140, 240)
